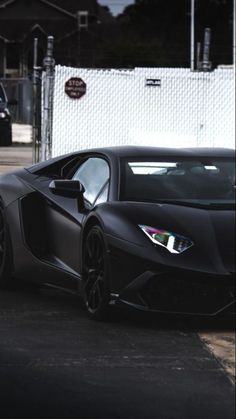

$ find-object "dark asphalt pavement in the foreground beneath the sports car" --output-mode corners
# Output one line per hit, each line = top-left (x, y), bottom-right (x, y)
(0, 283), (235, 419)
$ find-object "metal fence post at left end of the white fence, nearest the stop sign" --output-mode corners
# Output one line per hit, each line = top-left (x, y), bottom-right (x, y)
(40, 36), (55, 161)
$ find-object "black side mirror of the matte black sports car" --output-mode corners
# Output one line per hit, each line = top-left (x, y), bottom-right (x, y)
(49, 179), (85, 211)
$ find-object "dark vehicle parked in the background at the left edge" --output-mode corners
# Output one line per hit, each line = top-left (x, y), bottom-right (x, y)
(0, 83), (12, 146)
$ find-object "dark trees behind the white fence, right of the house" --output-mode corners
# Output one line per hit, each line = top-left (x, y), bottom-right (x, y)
(112, 0), (233, 66)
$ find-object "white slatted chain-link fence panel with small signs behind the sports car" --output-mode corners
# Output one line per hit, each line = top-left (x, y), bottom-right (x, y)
(48, 66), (235, 156)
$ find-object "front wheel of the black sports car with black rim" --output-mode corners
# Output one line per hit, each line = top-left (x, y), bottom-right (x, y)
(83, 226), (110, 320)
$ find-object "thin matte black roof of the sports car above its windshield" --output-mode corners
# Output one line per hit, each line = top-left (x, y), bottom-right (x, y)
(76, 146), (235, 158)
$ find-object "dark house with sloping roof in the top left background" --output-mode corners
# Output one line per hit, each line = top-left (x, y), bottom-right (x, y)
(0, 0), (115, 78)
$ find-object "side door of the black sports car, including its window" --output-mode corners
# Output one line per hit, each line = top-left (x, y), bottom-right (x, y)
(46, 156), (110, 273)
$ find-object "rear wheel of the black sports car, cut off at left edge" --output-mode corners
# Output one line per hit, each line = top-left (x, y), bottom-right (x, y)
(0, 200), (12, 289)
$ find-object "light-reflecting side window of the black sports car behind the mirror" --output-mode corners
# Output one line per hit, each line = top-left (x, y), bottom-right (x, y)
(72, 157), (110, 205)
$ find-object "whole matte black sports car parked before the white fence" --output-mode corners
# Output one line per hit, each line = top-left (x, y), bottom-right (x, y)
(0, 147), (235, 318)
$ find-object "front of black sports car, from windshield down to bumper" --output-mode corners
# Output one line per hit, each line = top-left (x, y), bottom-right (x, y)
(104, 156), (235, 315)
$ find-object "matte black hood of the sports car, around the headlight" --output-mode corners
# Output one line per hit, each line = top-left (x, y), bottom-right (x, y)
(98, 202), (235, 274)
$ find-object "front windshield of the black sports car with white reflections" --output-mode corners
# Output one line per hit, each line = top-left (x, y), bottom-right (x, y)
(120, 157), (235, 207)
